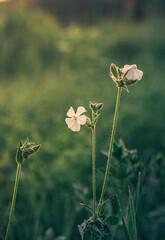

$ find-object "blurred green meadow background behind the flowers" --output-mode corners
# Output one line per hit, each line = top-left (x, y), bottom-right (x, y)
(0, 0), (165, 240)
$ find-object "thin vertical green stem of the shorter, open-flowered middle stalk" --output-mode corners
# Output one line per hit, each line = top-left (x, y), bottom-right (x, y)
(92, 113), (96, 212)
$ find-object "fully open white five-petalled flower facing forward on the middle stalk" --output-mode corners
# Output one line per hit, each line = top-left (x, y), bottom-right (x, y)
(65, 107), (87, 132)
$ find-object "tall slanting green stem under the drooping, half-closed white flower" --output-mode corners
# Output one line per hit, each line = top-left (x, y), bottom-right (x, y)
(98, 87), (122, 213)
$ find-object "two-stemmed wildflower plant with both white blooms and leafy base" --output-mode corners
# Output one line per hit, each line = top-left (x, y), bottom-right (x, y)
(65, 63), (143, 240)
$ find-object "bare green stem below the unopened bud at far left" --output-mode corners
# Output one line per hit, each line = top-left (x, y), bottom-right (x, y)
(5, 163), (21, 240)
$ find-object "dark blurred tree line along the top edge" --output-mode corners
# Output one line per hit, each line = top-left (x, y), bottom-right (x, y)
(9, 0), (165, 24)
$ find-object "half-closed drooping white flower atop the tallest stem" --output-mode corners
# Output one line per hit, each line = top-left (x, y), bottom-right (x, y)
(121, 64), (143, 81)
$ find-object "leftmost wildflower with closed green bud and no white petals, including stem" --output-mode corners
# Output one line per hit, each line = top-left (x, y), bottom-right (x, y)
(5, 138), (41, 240)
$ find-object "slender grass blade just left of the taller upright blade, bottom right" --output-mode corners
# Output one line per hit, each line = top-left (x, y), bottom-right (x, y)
(128, 186), (137, 240)
